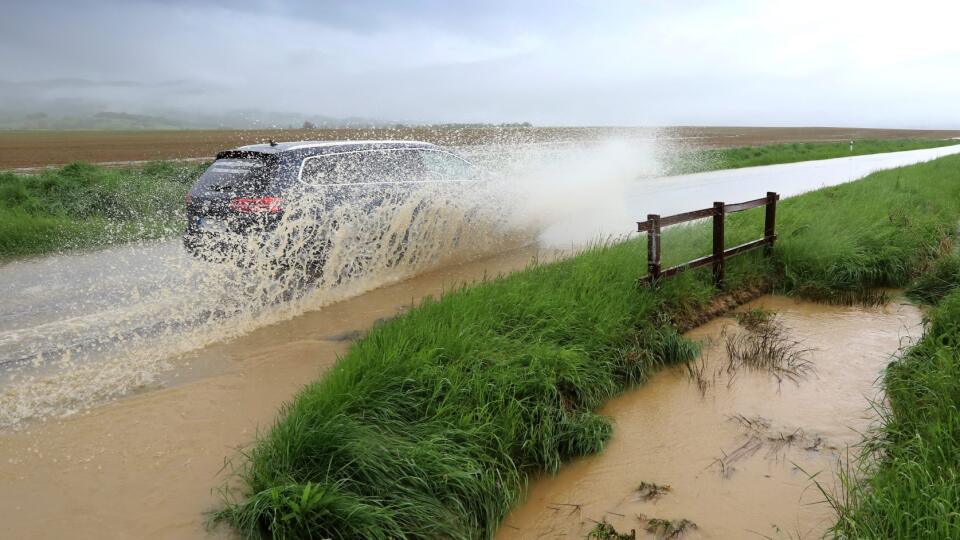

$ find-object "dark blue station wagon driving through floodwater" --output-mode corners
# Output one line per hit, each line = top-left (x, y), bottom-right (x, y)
(183, 141), (480, 268)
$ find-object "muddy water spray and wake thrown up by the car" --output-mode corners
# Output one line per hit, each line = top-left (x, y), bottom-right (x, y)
(0, 136), (659, 428)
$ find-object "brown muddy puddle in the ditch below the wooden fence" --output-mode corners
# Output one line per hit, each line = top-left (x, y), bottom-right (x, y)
(497, 296), (922, 540)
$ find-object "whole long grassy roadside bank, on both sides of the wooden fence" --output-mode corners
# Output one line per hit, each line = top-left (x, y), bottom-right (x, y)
(218, 157), (960, 538)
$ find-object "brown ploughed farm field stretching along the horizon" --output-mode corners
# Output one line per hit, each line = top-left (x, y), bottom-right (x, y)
(0, 126), (960, 169)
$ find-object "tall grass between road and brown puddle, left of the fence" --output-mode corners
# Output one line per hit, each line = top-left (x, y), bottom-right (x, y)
(220, 247), (759, 538)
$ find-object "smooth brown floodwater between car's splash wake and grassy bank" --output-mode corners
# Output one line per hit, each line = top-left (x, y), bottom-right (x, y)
(0, 249), (552, 540)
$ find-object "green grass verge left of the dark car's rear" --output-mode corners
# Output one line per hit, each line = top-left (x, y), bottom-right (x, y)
(0, 162), (204, 259)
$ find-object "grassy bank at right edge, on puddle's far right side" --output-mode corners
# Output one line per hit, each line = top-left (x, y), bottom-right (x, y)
(833, 255), (960, 538)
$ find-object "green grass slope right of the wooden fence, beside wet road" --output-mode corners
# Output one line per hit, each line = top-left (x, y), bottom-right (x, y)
(756, 156), (960, 302)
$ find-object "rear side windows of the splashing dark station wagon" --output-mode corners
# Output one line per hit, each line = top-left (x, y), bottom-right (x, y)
(300, 150), (423, 186)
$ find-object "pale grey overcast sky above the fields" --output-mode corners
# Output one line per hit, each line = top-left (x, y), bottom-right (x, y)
(0, 0), (960, 128)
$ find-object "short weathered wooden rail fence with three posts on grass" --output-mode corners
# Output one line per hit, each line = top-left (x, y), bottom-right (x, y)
(637, 191), (780, 289)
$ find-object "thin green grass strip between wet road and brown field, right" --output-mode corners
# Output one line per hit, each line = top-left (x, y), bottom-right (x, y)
(667, 139), (960, 174)
